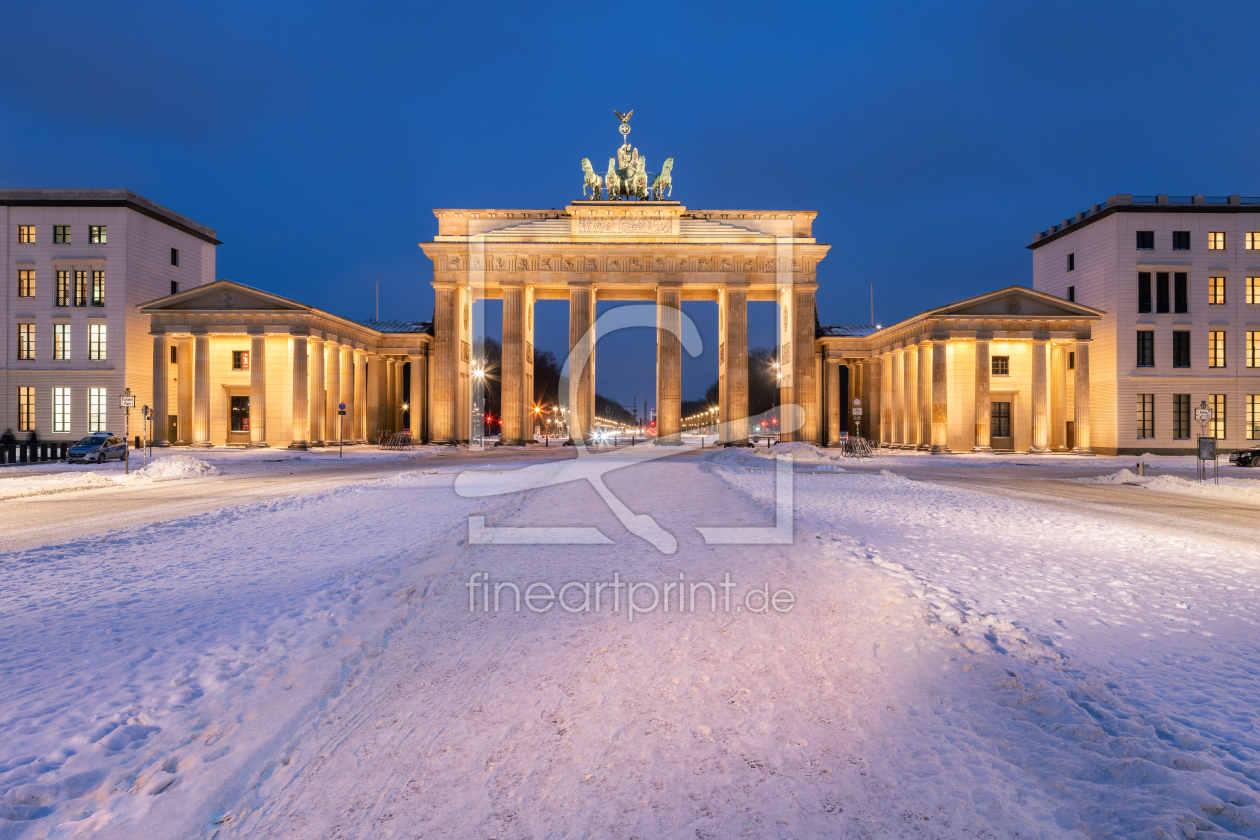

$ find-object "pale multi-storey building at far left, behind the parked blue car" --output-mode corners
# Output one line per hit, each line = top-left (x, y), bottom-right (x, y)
(0, 189), (219, 440)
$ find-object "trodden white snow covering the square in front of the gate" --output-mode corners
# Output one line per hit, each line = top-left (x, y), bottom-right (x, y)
(0, 446), (1260, 840)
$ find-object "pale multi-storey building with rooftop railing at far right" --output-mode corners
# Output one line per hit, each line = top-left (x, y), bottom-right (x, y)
(1028, 195), (1260, 455)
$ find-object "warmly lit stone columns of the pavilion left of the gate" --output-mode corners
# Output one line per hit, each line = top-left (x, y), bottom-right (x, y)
(152, 334), (427, 448)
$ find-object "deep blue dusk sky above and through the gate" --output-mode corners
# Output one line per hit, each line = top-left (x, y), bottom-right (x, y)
(0, 1), (1260, 404)
